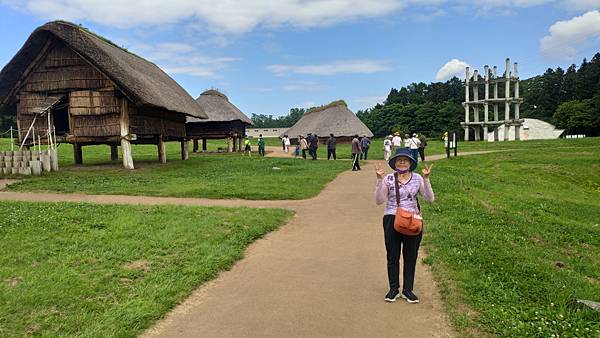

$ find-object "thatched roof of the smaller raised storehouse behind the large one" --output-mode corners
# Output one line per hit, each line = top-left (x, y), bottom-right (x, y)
(187, 89), (253, 125)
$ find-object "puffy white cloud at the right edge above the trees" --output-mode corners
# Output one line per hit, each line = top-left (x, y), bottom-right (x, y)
(540, 10), (600, 59)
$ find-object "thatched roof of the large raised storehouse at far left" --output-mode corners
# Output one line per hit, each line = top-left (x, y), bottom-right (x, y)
(0, 21), (206, 118)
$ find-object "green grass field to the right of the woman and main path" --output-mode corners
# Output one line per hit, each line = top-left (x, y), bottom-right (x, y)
(425, 138), (600, 337)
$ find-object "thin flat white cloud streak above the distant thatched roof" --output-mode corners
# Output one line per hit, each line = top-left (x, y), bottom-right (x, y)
(267, 60), (390, 76)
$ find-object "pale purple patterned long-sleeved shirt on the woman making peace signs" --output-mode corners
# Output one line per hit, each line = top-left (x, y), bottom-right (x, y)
(375, 173), (435, 215)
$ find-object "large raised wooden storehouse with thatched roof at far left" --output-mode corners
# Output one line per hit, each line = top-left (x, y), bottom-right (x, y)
(0, 21), (207, 169)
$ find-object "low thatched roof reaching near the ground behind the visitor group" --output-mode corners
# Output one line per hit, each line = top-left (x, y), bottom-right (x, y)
(281, 100), (373, 137)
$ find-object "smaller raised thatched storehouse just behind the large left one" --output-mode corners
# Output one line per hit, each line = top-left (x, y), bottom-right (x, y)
(186, 89), (253, 152)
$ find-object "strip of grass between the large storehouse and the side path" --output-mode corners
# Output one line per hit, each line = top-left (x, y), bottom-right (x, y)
(8, 154), (350, 200)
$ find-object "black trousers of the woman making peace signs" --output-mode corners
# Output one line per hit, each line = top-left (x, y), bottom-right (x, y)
(383, 215), (423, 291)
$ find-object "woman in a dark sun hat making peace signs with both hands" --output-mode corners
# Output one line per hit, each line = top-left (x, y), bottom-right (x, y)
(375, 149), (434, 303)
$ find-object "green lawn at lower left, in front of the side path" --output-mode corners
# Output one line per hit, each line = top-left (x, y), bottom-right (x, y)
(0, 202), (292, 337)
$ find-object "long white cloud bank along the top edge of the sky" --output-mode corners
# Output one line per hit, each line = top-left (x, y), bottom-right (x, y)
(0, 0), (572, 34)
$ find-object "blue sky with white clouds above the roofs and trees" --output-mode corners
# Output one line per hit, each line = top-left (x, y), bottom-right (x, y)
(0, 0), (600, 116)
